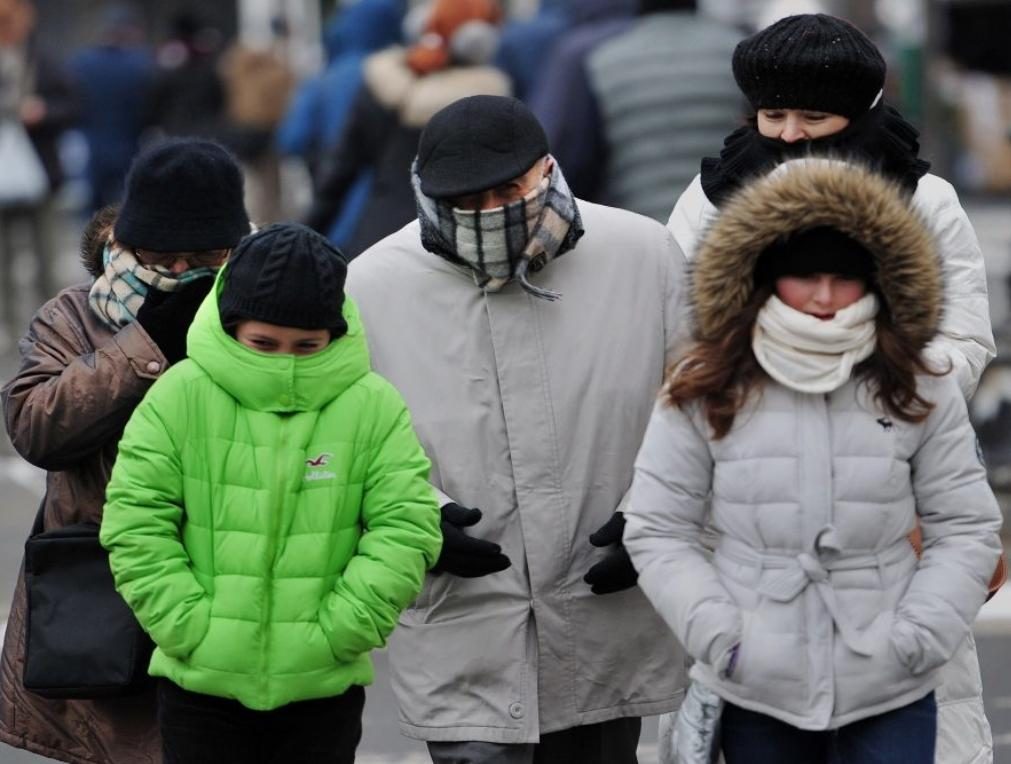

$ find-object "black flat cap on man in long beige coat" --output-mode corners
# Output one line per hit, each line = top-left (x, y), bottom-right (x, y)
(418, 95), (548, 199)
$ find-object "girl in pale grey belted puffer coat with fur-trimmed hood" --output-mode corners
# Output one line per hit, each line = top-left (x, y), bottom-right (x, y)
(625, 160), (1001, 764)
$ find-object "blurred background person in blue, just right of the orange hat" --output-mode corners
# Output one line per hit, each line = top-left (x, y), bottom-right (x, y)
(495, 0), (577, 101)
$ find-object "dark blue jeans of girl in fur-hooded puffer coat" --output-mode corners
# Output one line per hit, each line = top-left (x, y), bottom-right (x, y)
(722, 692), (937, 764)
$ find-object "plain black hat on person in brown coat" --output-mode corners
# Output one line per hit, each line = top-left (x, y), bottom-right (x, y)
(113, 138), (250, 252)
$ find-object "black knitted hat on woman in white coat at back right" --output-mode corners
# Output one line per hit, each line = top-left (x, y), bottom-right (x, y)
(733, 13), (885, 119)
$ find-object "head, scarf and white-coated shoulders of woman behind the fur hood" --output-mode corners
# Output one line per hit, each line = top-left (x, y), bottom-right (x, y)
(667, 13), (996, 397)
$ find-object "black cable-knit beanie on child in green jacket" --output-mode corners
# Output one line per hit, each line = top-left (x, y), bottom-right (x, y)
(217, 223), (348, 341)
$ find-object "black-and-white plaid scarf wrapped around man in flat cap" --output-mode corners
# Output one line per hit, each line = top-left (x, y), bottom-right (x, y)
(411, 154), (583, 300)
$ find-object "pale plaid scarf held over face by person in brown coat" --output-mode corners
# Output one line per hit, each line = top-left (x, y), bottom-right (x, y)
(88, 241), (216, 331)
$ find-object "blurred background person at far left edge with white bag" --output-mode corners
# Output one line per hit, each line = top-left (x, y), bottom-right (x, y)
(0, 0), (78, 333)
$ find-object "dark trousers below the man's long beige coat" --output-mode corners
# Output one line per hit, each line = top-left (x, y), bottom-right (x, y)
(429, 719), (642, 764)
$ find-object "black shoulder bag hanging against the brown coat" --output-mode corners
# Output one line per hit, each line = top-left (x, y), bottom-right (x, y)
(22, 507), (154, 698)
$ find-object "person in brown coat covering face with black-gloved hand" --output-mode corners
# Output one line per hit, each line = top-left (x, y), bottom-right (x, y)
(0, 139), (250, 764)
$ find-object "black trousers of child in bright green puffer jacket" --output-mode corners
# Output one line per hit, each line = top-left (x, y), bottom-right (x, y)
(158, 679), (365, 764)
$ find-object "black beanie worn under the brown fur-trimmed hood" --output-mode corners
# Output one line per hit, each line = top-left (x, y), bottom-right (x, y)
(755, 225), (877, 286)
